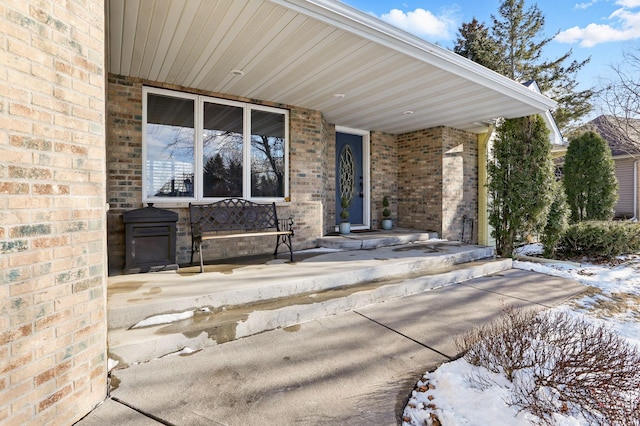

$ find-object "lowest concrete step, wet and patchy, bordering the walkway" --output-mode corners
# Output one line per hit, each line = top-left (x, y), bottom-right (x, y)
(108, 253), (511, 367)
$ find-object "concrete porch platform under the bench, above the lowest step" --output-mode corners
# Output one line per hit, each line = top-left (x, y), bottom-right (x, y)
(107, 240), (494, 329)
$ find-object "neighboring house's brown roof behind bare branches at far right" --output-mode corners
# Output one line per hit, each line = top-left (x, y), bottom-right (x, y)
(579, 115), (640, 157)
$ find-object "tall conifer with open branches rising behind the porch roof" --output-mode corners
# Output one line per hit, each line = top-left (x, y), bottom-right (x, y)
(454, 0), (594, 130)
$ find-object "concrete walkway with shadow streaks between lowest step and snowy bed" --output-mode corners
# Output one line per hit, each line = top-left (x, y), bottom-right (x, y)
(77, 269), (584, 426)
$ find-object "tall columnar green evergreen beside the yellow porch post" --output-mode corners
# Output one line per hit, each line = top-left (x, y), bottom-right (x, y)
(488, 115), (555, 257)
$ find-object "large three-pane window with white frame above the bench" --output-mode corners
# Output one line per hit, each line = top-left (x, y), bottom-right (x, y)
(143, 87), (289, 202)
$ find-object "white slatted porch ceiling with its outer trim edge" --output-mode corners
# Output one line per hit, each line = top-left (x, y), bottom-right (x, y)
(107, 0), (555, 133)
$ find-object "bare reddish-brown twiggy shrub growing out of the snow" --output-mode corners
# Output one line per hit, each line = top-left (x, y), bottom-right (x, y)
(456, 308), (640, 425)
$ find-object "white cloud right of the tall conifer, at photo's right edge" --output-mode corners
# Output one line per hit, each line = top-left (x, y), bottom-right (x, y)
(555, 4), (640, 47)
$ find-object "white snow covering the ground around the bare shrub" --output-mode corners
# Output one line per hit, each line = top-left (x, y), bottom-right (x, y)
(403, 247), (640, 426)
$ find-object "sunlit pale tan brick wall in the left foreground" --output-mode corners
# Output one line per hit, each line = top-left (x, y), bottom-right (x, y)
(0, 0), (107, 425)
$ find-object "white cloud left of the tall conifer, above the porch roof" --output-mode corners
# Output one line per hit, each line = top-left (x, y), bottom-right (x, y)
(380, 8), (458, 41)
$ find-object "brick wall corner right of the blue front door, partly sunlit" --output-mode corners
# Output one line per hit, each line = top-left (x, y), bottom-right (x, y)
(398, 127), (478, 241)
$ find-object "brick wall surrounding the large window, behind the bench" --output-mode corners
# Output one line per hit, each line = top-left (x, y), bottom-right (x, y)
(107, 75), (328, 274)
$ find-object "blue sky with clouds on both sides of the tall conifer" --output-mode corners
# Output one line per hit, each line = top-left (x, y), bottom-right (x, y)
(342, 0), (640, 103)
